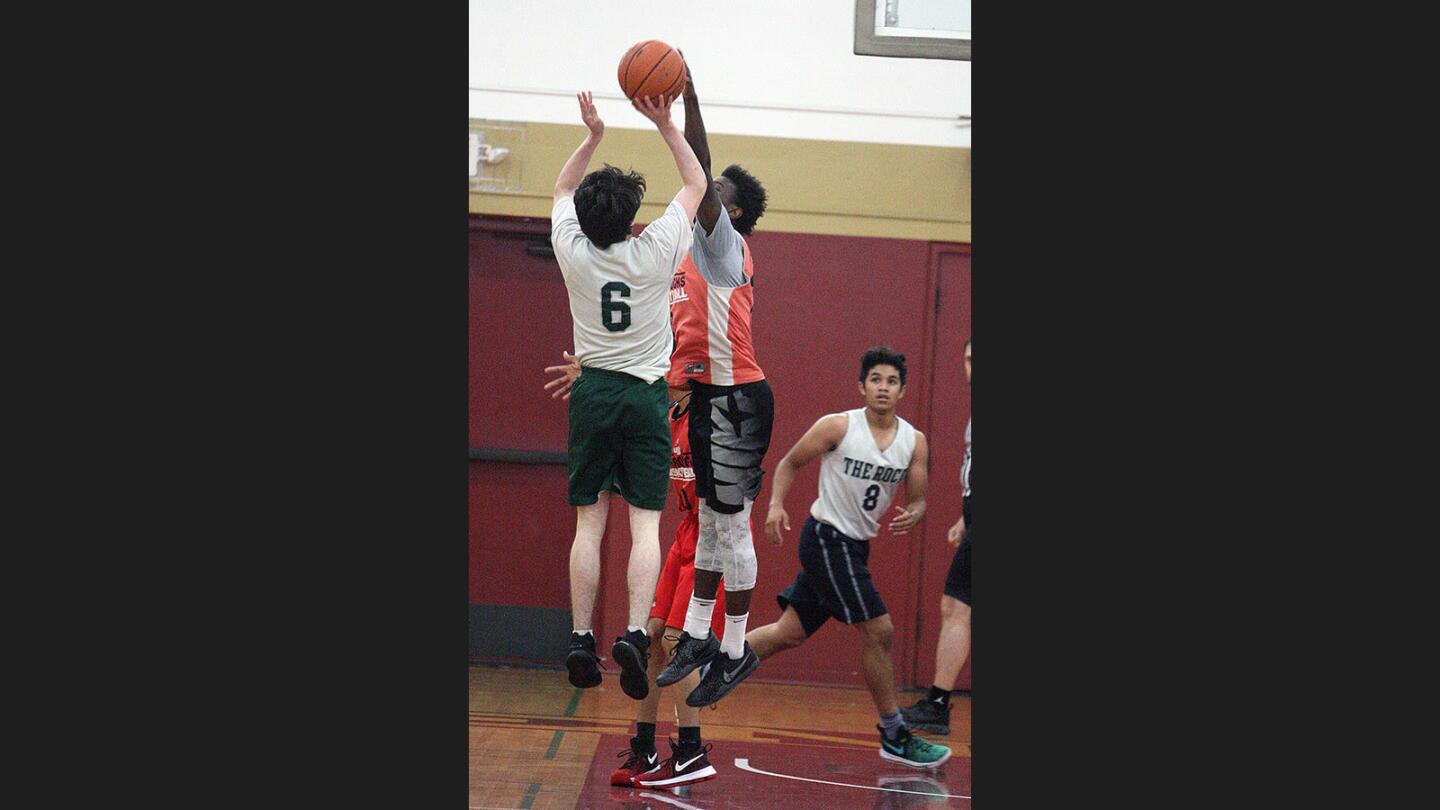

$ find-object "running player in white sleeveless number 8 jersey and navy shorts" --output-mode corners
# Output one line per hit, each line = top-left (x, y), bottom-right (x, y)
(746, 346), (950, 768)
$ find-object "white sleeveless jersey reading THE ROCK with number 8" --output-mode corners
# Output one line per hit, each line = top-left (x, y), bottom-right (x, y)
(811, 408), (914, 540)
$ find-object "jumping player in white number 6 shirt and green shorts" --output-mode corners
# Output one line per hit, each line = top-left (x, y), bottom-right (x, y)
(550, 92), (708, 700)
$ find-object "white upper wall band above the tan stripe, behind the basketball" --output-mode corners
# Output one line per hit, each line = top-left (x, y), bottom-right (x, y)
(469, 0), (971, 147)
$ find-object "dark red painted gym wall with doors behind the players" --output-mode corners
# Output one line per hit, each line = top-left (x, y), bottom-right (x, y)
(469, 216), (971, 687)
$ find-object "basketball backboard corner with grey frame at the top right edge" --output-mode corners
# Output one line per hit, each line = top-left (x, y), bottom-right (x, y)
(855, 0), (971, 62)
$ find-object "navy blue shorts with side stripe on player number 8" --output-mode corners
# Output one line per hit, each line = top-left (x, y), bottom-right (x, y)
(775, 517), (890, 637)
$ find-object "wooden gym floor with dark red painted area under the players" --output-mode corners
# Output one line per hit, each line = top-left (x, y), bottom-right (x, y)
(469, 666), (971, 810)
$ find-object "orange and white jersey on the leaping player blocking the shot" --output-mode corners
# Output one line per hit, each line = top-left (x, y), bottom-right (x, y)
(665, 234), (765, 388)
